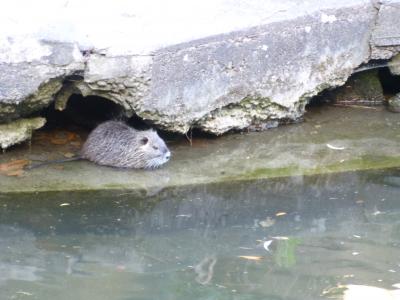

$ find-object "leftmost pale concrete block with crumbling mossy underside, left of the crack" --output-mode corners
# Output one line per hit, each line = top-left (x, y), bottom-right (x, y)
(0, 36), (84, 123)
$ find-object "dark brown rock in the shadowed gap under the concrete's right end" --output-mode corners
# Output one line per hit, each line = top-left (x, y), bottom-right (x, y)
(328, 70), (385, 106)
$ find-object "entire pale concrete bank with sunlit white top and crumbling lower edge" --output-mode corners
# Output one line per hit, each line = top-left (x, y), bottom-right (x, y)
(0, 0), (400, 138)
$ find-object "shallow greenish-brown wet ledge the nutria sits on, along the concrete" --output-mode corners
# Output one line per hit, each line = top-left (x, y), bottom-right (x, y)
(0, 106), (400, 195)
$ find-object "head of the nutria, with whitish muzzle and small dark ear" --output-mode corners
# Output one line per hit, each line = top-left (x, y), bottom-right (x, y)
(139, 129), (171, 169)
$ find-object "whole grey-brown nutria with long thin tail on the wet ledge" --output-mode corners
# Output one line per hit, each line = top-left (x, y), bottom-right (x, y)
(29, 121), (171, 169)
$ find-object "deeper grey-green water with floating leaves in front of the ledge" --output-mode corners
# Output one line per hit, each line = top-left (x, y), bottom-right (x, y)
(0, 170), (400, 300)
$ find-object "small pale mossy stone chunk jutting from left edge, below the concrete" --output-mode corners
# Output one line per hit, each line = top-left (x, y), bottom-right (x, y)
(0, 118), (46, 150)
